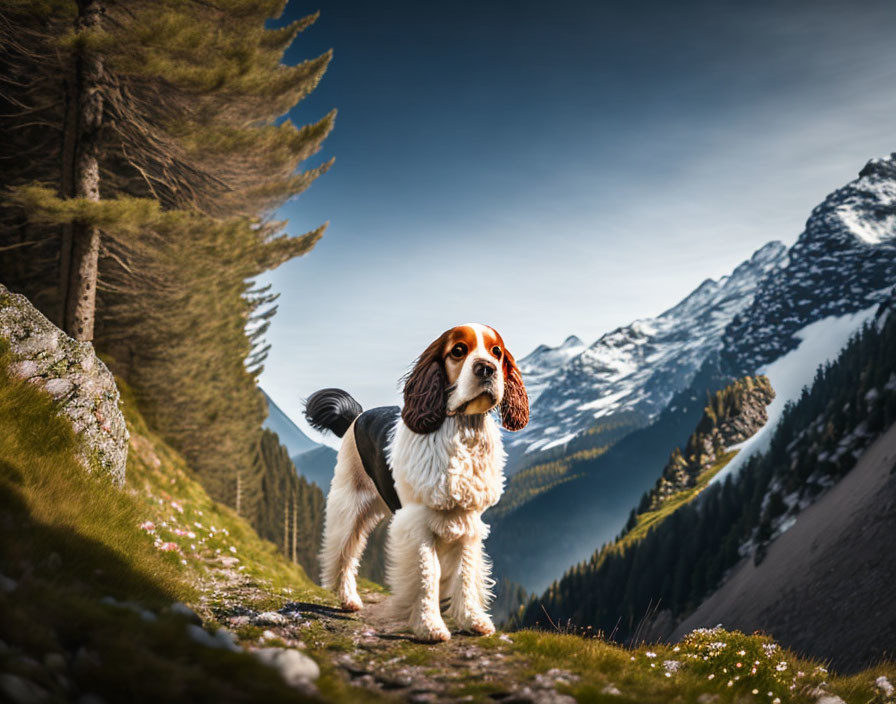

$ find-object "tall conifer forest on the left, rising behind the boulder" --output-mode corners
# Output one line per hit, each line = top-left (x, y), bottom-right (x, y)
(0, 0), (335, 572)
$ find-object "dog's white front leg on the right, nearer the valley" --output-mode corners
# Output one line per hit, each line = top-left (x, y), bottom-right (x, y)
(449, 529), (495, 636)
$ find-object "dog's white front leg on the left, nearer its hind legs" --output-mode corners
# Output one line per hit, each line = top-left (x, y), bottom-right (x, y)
(387, 505), (451, 642)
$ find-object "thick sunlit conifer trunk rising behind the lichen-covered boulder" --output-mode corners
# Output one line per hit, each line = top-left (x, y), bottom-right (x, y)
(60, 0), (105, 340)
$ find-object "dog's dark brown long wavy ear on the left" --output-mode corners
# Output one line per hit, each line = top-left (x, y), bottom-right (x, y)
(401, 333), (448, 434)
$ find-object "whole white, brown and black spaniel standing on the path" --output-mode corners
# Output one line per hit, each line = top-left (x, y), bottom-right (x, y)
(305, 323), (529, 642)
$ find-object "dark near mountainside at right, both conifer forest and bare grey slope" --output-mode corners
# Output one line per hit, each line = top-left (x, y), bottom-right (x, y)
(517, 297), (896, 669)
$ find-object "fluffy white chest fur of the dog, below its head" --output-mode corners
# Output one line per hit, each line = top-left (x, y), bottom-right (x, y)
(386, 414), (506, 513)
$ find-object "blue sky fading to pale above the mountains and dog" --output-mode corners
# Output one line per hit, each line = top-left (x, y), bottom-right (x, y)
(261, 0), (896, 446)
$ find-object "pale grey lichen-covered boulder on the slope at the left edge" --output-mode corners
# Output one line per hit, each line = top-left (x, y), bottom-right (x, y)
(0, 285), (128, 486)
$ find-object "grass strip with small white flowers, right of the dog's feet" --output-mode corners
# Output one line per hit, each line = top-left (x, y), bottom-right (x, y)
(500, 628), (896, 704)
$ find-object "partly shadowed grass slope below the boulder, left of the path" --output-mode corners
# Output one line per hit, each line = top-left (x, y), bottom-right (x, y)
(0, 350), (328, 702)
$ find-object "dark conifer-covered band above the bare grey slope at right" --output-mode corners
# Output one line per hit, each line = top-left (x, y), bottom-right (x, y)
(512, 301), (896, 640)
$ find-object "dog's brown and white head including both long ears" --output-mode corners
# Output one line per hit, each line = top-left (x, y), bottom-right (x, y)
(401, 323), (529, 433)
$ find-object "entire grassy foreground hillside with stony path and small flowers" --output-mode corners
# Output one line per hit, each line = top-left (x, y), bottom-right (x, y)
(0, 344), (896, 704)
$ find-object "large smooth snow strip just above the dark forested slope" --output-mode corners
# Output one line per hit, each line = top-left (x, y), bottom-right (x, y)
(711, 304), (878, 482)
